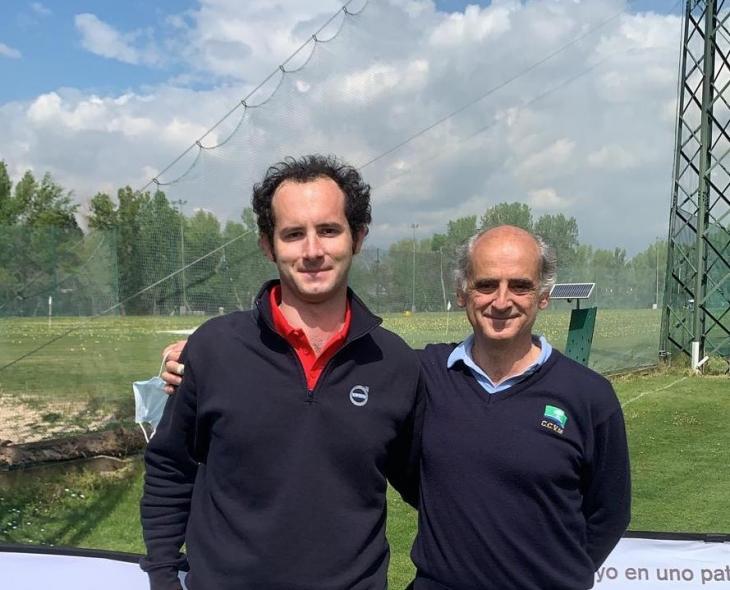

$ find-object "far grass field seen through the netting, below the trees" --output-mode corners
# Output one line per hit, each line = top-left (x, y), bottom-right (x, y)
(0, 312), (659, 442)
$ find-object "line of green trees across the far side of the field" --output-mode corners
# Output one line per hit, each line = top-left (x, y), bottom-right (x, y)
(0, 161), (666, 316)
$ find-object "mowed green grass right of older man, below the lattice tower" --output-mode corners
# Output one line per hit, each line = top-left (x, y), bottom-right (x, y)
(614, 372), (730, 533)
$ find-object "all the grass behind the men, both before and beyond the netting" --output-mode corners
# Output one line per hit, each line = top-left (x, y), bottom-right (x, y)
(0, 310), (730, 588)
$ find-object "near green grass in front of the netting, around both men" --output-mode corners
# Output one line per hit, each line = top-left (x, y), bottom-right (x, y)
(0, 371), (730, 588)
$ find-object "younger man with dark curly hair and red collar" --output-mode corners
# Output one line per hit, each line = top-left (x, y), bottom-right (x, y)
(141, 156), (421, 590)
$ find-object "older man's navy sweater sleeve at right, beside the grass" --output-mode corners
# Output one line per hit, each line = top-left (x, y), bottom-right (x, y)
(583, 408), (631, 570)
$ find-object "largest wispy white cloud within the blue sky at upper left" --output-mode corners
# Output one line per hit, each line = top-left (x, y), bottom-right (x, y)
(74, 13), (160, 65)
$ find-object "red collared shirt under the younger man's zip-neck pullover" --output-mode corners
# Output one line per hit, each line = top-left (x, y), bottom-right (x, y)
(269, 285), (351, 391)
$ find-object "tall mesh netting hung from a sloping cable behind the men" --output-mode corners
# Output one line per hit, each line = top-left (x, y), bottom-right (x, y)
(0, 0), (663, 441)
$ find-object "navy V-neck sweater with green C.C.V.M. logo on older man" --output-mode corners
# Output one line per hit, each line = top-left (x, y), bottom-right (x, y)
(412, 345), (630, 590)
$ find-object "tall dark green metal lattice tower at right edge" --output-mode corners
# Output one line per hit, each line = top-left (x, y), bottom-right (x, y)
(661, 0), (730, 368)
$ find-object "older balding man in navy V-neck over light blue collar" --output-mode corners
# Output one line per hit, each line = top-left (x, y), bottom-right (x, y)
(412, 226), (630, 590)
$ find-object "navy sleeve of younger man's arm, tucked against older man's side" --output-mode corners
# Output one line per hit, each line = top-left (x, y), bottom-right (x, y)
(386, 370), (426, 508)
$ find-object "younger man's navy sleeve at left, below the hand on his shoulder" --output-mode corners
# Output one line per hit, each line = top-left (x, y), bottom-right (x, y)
(140, 347), (198, 590)
